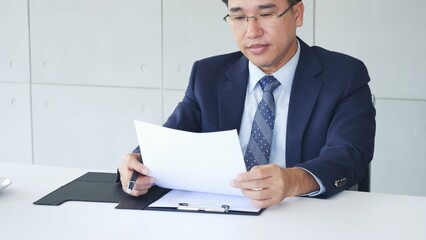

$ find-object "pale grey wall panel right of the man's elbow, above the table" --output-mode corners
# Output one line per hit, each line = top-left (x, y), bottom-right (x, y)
(371, 99), (426, 196)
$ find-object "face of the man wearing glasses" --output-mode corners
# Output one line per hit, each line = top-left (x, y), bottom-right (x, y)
(228, 0), (304, 74)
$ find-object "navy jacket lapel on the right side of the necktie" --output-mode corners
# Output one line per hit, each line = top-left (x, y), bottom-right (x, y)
(286, 39), (323, 167)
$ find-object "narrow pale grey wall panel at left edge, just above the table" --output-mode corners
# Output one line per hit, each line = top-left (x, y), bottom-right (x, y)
(0, 83), (32, 163)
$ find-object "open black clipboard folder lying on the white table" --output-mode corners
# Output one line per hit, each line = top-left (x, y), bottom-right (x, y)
(34, 172), (264, 215)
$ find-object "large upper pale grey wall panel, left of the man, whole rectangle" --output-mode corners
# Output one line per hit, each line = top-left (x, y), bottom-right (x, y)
(30, 0), (162, 88)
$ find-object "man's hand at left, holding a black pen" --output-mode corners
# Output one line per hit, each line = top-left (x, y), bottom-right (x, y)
(118, 153), (155, 197)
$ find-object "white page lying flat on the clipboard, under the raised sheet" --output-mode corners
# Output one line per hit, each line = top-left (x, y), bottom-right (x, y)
(149, 190), (261, 212)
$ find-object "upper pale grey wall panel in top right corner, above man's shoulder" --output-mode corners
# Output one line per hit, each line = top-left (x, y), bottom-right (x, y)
(315, 0), (426, 100)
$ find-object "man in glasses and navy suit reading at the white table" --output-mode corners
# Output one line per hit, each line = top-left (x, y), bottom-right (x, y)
(119, 0), (375, 207)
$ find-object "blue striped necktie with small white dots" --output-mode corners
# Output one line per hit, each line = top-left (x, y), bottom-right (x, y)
(244, 75), (280, 171)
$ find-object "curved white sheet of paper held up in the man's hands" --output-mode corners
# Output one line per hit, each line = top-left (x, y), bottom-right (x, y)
(135, 121), (246, 196)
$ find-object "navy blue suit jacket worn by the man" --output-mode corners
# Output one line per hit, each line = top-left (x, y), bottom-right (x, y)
(164, 39), (375, 197)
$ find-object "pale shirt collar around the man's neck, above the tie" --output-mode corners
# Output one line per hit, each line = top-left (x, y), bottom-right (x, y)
(247, 40), (300, 94)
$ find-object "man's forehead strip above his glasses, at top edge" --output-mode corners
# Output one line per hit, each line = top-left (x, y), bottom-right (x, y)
(228, 0), (287, 12)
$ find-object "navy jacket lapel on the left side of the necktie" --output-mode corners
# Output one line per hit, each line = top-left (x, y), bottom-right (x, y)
(218, 56), (249, 131)
